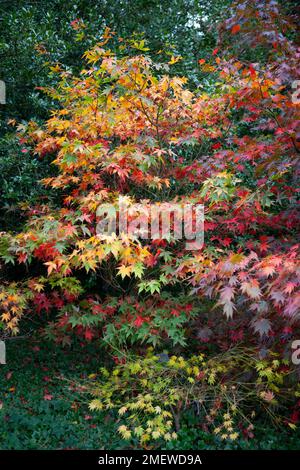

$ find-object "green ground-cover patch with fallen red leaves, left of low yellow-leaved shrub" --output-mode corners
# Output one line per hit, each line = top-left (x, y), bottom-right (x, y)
(0, 340), (124, 449)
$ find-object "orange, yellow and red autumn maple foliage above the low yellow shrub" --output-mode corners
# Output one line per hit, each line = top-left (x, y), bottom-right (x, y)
(0, 1), (300, 440)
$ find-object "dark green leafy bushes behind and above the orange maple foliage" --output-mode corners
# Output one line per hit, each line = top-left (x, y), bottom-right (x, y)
(0, 0), (230, 228)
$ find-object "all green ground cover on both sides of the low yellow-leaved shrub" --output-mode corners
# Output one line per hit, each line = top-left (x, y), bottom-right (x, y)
(0, 339), (300, 450)
